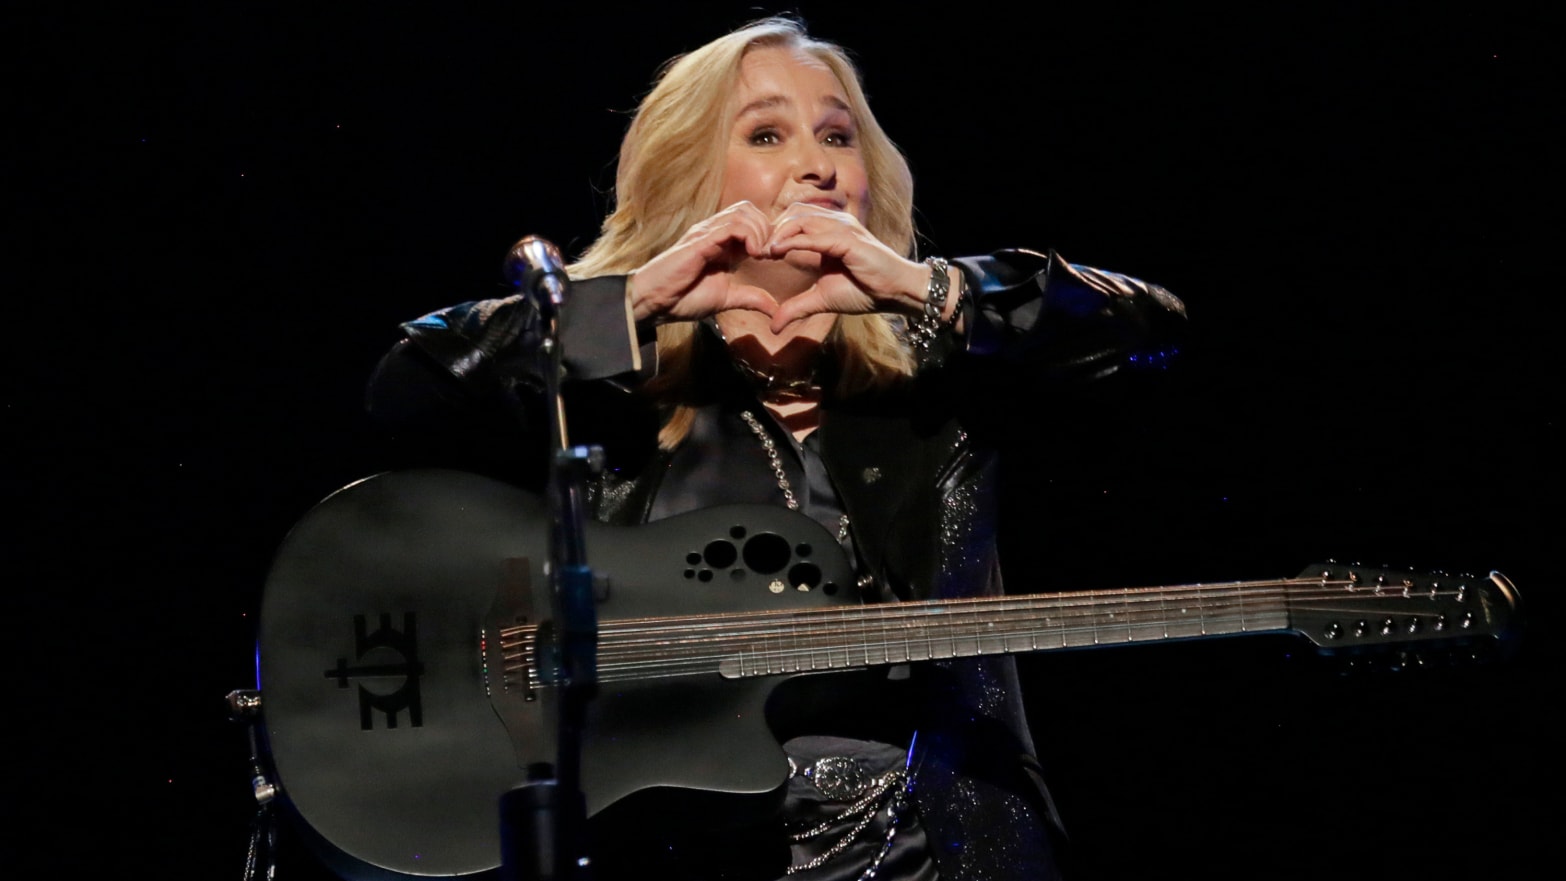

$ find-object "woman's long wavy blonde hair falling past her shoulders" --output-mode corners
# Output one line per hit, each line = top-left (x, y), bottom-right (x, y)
(567, 17), (915, 449)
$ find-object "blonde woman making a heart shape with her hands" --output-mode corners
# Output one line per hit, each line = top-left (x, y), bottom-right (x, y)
(370, 19), (1184, 879)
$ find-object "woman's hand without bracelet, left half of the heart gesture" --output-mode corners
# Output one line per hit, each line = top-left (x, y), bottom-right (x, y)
(631, 202), (778, 321)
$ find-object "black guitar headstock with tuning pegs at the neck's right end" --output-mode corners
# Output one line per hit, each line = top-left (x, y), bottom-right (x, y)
(1289, 562), (1519, 663)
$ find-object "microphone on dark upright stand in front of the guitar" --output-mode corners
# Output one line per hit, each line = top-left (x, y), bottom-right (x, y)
(500, 236), (603, 881)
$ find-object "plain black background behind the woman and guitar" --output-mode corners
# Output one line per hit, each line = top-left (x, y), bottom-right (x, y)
(6, 0), (1561, 881)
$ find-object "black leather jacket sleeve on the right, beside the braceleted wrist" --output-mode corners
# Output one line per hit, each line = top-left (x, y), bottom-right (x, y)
(952, 249), (1185, 379)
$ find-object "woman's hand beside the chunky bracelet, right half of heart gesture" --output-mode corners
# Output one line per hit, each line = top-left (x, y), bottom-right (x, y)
(766, 202), (930, 333)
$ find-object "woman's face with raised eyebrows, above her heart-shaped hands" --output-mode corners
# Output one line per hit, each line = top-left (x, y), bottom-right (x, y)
(720, 47), (869, 222)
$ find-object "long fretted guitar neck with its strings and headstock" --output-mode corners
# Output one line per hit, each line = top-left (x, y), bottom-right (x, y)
(514, 565), (1516, 681)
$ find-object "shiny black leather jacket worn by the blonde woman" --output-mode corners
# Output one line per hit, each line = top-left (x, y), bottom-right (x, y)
(368, 250), (1185, 879)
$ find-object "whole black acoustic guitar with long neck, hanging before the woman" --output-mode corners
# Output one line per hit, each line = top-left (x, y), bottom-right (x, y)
(257, 469), (1517, 878)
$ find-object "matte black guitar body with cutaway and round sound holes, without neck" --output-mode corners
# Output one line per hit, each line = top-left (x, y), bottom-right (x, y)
(257, 469), (858, 876)
